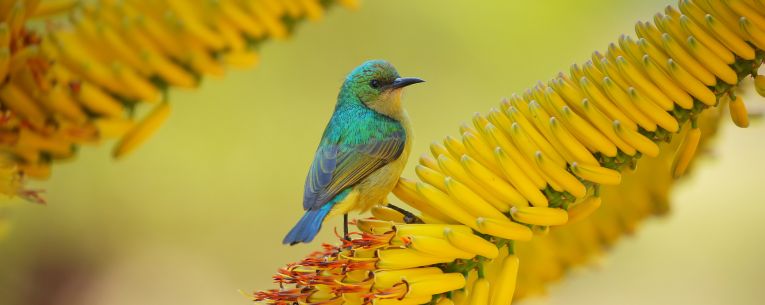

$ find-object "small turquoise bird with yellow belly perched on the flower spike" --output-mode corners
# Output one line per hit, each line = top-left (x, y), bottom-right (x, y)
(282, 60), (424, 245)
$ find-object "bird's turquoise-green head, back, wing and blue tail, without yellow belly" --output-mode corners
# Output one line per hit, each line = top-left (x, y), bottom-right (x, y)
(283, 60), (421, 244)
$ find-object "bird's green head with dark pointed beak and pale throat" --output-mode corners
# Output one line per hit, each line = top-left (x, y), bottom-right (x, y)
(340, 60), (424, 118)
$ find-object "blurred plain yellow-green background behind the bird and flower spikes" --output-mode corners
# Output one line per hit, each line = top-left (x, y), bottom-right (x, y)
(0, 0), (765, 305)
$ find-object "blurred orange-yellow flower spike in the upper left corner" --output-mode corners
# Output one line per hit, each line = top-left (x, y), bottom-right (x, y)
(0, 0), (357, 200)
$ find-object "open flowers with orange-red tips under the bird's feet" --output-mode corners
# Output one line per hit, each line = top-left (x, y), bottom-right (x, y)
(254, 206), (518, 305)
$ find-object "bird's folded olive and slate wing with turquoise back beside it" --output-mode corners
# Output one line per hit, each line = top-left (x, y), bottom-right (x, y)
(303, 123), (406, 210)
